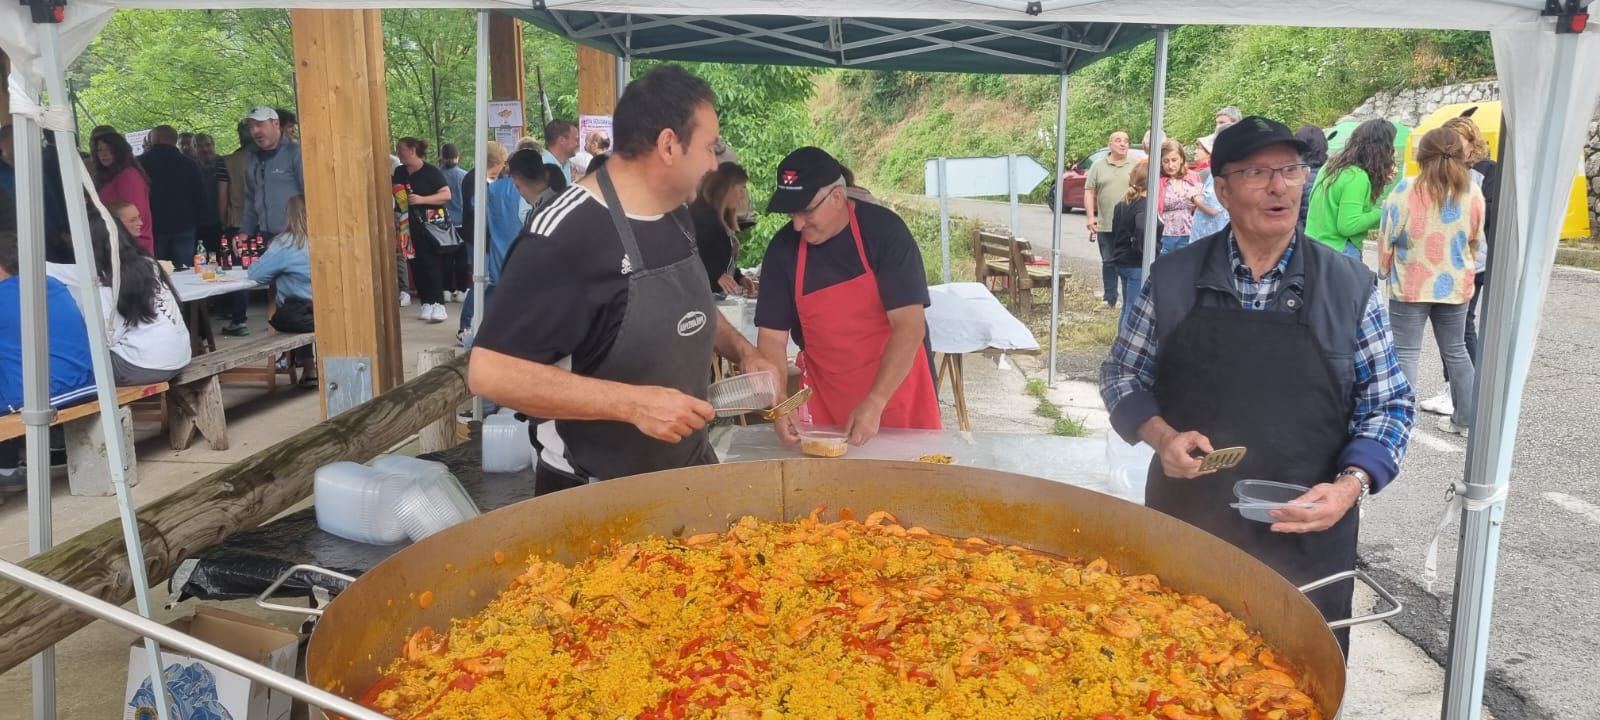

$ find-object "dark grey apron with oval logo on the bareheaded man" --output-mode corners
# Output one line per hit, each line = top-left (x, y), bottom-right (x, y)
(534, 166), (717, 494)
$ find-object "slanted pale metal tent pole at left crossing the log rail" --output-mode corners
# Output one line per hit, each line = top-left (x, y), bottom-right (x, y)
(38, 22), (171, 720)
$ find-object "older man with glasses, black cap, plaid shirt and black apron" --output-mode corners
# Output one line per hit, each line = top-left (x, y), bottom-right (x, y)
(1101, 117), (1416, 651)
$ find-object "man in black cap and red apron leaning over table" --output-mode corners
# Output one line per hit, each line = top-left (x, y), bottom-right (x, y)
(755, 147), (941, 445)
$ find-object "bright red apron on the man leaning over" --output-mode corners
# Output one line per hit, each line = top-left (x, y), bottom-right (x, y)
(795, 203), (942, 429)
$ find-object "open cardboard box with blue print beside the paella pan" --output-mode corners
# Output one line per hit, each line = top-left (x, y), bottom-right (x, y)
(123, 606), (299, 720)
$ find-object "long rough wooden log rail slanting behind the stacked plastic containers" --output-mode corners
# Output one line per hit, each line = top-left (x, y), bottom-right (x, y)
(0, 355), (469, 672)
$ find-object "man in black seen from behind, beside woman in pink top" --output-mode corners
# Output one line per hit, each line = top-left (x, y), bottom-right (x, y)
(139, 125), (206, 269)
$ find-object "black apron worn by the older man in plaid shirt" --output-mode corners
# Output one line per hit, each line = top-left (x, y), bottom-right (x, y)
(1144, 293), (1360, 656)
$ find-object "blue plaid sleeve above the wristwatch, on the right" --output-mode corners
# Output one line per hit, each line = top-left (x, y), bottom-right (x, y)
(1339, 285), (1416, 491)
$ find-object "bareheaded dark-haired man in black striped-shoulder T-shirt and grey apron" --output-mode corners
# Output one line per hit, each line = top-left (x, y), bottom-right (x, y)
(467, 66), (776, 494)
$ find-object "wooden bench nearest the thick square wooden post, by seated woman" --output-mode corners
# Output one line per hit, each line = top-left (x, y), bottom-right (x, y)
(166, 333), (317, 450)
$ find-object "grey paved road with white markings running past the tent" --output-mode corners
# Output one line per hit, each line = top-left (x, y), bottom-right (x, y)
(952, 200), (1600, 720)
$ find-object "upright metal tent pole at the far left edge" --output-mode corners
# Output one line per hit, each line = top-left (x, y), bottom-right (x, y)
(10, 67), (56, 720)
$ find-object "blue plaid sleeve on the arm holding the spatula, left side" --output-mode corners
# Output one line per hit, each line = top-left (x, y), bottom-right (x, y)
(1101, 282), (1158, 443)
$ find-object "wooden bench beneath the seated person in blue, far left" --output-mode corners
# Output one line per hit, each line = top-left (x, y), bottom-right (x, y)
(0, 382), (166, 496)
